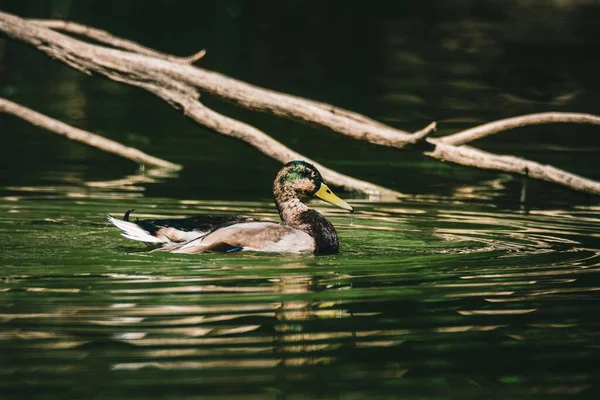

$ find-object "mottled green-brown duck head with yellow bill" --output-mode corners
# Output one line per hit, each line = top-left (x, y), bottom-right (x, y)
(273, 161), (354, 212)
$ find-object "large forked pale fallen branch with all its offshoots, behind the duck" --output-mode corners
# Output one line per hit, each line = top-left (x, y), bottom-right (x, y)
(0, 13), (600, 196)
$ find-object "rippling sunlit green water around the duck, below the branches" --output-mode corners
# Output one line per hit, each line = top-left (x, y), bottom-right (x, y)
(0, 191), (600, 399)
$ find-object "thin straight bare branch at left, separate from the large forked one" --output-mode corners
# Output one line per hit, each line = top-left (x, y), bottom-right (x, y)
(0, 98), (181, 170)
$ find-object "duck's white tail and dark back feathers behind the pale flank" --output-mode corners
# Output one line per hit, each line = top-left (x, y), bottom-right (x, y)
(108, 210), (257, 244)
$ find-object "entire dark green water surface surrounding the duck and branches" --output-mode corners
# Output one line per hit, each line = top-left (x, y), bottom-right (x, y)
(0, 0), (600, 399)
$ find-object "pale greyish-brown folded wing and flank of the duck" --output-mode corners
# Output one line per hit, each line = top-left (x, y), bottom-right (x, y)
(164, 221), (316, 254)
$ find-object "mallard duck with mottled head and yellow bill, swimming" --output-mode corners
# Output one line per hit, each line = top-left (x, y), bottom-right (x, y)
(108, 161), (354, 254)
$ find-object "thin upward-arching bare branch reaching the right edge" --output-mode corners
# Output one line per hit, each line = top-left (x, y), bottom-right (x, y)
(438, 112), (600, 146)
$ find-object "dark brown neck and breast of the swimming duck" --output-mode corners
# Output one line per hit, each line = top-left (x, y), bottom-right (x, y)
(275, 198), (339, 254)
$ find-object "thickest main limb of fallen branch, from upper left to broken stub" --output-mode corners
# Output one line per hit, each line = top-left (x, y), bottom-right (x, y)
(0, 12), (413, 148)
